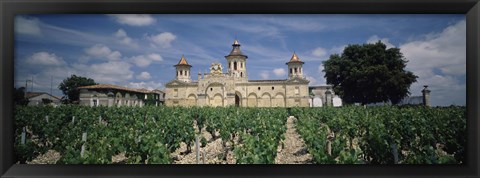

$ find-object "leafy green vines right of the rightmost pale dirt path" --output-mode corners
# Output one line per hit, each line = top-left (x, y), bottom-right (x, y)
(292, 106), (466, 164)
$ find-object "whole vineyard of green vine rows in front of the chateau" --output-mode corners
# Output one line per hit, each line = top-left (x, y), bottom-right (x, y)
(15, 105), (466, 164)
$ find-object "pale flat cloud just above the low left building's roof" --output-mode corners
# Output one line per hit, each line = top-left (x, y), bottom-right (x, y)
(72, 61), (133, 84)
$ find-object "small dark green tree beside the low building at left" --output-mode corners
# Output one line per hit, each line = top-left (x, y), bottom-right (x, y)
(58, 75), (97, 103)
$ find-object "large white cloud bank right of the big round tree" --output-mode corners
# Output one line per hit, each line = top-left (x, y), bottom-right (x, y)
(400, 20), (466, 105)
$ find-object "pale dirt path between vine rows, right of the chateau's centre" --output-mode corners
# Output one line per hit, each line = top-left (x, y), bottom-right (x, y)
(275, 116), (313, 164)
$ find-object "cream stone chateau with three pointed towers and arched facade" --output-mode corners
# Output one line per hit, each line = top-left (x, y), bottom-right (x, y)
(165, 40), (311, 107)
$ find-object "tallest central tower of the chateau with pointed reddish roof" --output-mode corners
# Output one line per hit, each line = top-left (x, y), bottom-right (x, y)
(225, 39), (248, 79)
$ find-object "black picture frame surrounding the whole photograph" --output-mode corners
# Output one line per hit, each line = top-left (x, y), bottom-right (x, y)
(0, 0), (480, 177)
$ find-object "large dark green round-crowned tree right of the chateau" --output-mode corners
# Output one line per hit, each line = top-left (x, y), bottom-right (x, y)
(323, 41), (418, 104)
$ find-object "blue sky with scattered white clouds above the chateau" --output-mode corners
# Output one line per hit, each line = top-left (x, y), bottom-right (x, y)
(14, 14), (466, 106)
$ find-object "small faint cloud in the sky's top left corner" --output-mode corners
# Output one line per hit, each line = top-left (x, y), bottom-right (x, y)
(14, 16), (42, 36)
